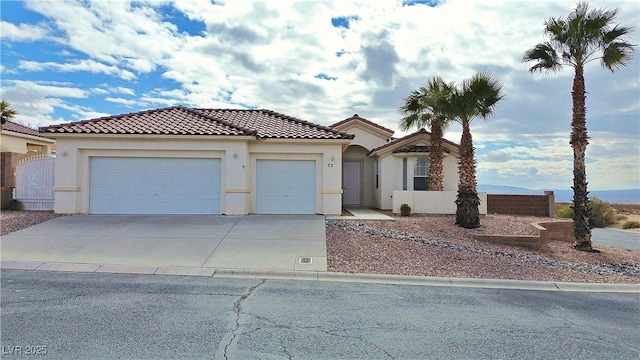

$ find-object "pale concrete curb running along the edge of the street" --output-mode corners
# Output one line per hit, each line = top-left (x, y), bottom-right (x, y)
(0, 261), (640, 294)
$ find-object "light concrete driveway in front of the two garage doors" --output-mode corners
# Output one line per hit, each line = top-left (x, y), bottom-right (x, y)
(1, 215), (327, 275)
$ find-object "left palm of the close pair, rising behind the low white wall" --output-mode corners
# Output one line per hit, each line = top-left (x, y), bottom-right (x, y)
(399, 77), (453, 191)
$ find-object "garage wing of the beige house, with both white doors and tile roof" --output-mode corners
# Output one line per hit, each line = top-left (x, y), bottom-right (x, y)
(40, 106), (354, 215)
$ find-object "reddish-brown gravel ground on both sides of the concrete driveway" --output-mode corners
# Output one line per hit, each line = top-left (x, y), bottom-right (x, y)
(0, 211), (640, 284)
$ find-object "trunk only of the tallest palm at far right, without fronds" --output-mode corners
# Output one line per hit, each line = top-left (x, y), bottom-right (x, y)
(571, 65), (593, 251)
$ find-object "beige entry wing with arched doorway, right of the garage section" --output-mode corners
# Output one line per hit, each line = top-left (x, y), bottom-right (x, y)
(330, 114), (486, 214)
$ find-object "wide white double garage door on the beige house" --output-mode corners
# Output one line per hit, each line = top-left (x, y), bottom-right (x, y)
(89, 157), (221, 214)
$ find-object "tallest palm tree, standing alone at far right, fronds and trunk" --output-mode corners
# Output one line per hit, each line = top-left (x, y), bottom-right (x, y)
(523, 2), (634, 251)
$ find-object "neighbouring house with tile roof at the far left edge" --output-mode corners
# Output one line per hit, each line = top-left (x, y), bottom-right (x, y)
(0, 121), (56, 155)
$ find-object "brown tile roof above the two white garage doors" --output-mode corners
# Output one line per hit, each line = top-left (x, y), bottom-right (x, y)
(40, 106), (353, 139)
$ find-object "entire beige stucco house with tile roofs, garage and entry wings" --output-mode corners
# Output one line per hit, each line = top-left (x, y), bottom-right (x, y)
(40, 106), (486, 215)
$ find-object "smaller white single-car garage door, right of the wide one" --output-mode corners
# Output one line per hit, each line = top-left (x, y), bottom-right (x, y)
(256, 160), (316, 214)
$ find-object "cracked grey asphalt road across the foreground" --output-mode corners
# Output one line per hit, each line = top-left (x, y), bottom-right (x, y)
(1, 270), (640, 359)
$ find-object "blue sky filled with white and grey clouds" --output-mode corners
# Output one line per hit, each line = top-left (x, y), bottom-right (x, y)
(0, 0), (640, 190)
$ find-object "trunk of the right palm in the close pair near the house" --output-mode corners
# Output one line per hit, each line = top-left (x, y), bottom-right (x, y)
(456, 121), (480, 229)
